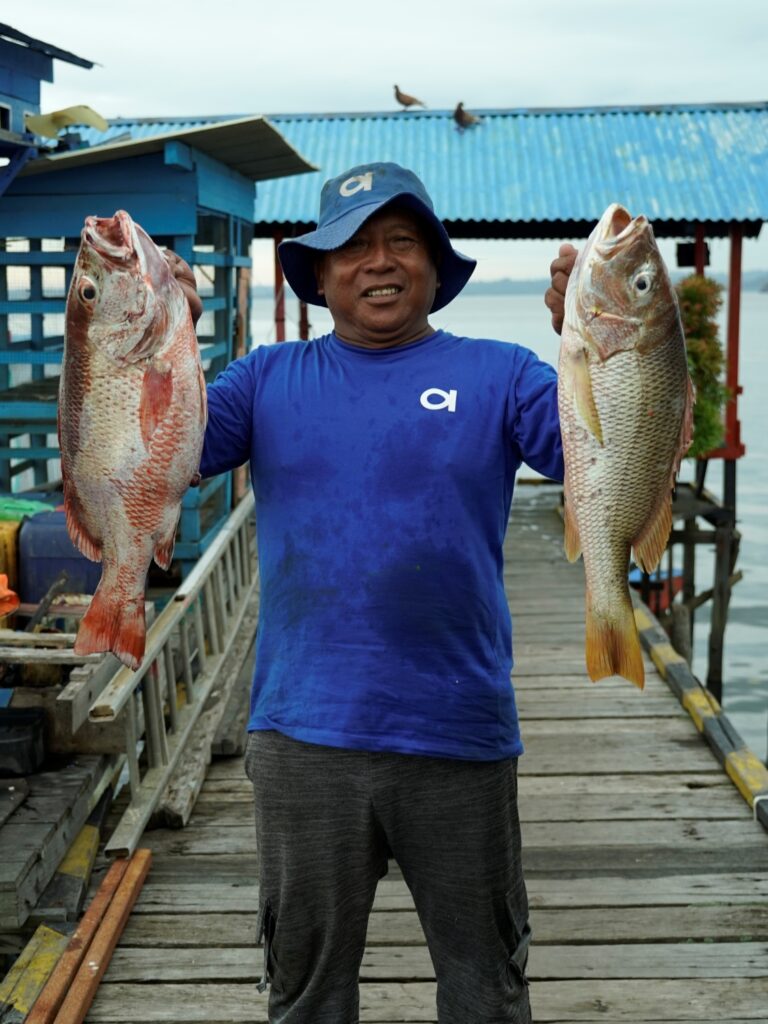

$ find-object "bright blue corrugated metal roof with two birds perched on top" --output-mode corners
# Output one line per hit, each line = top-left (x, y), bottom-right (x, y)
(69, 102), (768, 236)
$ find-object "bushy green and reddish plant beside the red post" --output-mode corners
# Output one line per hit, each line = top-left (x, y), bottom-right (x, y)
(676, 273), (729, 459)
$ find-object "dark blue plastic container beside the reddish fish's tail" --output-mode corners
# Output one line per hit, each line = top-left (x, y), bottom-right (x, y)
(17, 510), (101, 604)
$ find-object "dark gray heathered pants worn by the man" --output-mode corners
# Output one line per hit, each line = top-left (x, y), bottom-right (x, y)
(246, 732), (530, 1024)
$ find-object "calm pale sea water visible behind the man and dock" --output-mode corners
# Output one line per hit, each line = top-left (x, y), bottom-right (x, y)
(251, 292), (768, 761)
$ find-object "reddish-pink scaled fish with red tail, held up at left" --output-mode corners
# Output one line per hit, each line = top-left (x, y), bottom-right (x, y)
(58, 210), (206, 669)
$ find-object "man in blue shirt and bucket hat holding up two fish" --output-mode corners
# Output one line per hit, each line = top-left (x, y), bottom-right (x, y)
(171, 163), (567, 1024)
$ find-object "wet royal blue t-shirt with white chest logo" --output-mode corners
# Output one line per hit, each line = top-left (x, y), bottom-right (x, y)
(201, 331), (563, 760)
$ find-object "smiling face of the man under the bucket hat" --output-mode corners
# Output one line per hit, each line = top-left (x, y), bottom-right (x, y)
(316, 207), (437, 348)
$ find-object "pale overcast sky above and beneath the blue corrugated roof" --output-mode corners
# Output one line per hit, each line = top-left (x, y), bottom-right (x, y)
(7, 0), (768, 284)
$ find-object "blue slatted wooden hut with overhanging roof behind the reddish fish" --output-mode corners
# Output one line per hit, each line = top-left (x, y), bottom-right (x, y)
(0, 117), (314, 563)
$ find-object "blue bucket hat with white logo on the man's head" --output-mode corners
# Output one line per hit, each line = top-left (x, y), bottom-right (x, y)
(278, 163), (477, 312)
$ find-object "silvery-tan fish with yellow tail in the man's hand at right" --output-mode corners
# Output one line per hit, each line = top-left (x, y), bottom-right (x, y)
(558, 204), (693, 687)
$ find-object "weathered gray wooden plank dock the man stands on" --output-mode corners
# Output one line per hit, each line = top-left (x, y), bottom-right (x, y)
(87, 487), (768, 1024)
